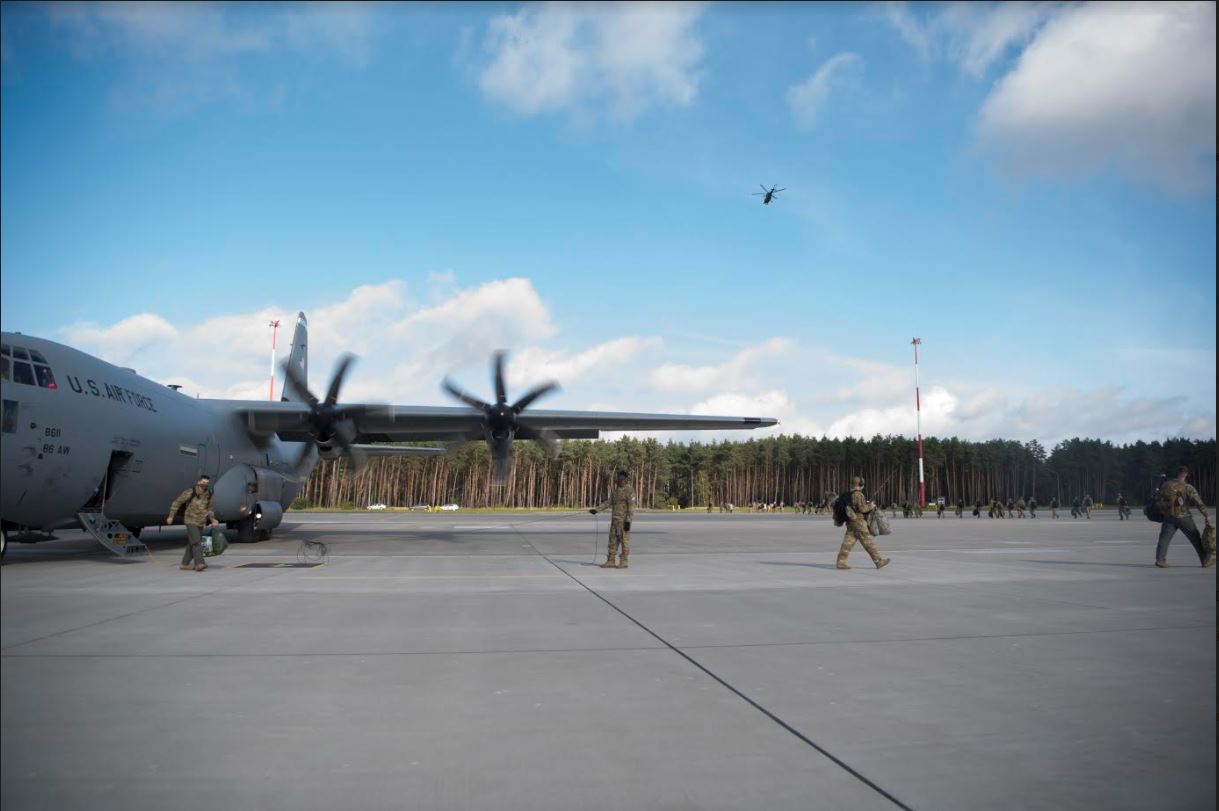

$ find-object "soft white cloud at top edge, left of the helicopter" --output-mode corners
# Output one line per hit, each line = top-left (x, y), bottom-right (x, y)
(479, 4), (702, 120)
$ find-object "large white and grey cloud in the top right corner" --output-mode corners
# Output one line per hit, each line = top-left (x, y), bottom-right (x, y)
(978, 2), (1215, 190)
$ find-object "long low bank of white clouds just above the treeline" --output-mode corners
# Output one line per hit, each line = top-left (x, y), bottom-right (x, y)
(52, 277), (1215, 446)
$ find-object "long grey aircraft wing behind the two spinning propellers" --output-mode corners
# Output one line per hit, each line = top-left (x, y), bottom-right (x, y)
(232, 401), (779, 443)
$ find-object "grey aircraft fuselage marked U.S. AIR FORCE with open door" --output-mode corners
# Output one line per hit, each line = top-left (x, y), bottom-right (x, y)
(0, 333), (309, 531)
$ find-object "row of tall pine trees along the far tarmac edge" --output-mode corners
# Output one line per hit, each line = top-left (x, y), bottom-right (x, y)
(293, 435), (1215, 509)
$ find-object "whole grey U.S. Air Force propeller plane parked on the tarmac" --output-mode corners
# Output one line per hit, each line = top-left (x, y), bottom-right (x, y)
(0, 313), (778, 557)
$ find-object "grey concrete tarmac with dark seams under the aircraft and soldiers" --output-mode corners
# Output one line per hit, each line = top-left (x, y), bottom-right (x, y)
(0, 511), (1217, 811)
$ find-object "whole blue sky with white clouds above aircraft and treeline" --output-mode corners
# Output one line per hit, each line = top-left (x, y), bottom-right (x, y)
(0, 4), (1215, 441)
